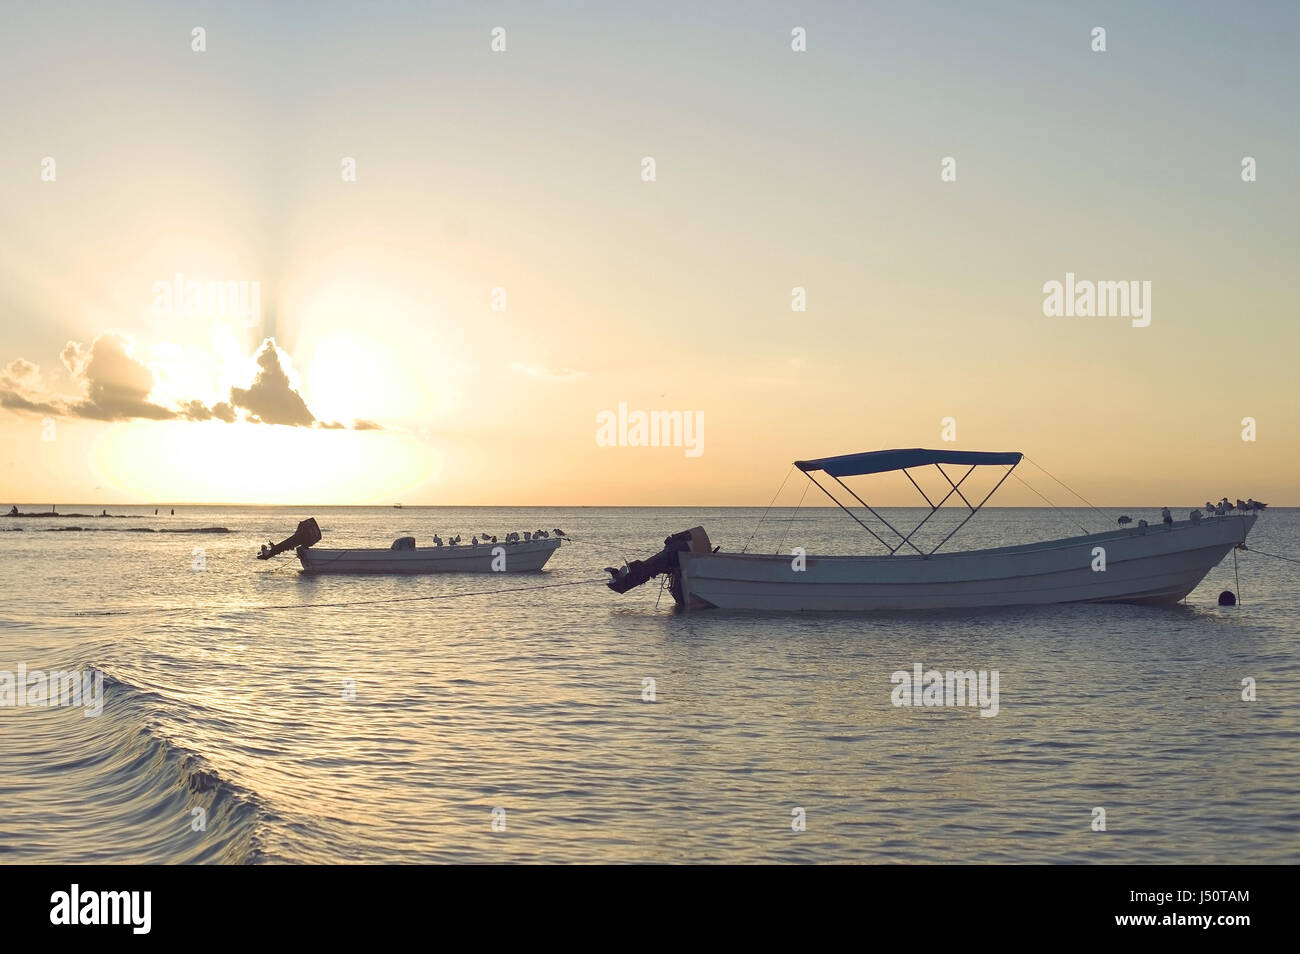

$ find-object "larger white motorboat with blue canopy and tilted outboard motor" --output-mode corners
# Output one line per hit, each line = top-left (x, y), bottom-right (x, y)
(607, 447), (1256, 612)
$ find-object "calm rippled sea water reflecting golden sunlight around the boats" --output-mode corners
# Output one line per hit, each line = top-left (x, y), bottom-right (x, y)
(0, 506), (1300, 863)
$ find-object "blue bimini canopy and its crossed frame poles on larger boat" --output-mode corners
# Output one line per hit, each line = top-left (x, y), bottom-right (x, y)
(794, 447), (1023, 558)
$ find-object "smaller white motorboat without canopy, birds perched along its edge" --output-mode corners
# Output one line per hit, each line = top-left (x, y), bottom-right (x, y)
(257, 517), (562, 573)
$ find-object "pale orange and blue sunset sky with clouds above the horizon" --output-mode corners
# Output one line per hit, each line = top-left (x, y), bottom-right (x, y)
(0, 0), (1300, 508)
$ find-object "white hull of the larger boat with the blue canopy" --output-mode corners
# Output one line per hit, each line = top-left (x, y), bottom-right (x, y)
(679, 515), (1256, 612)
